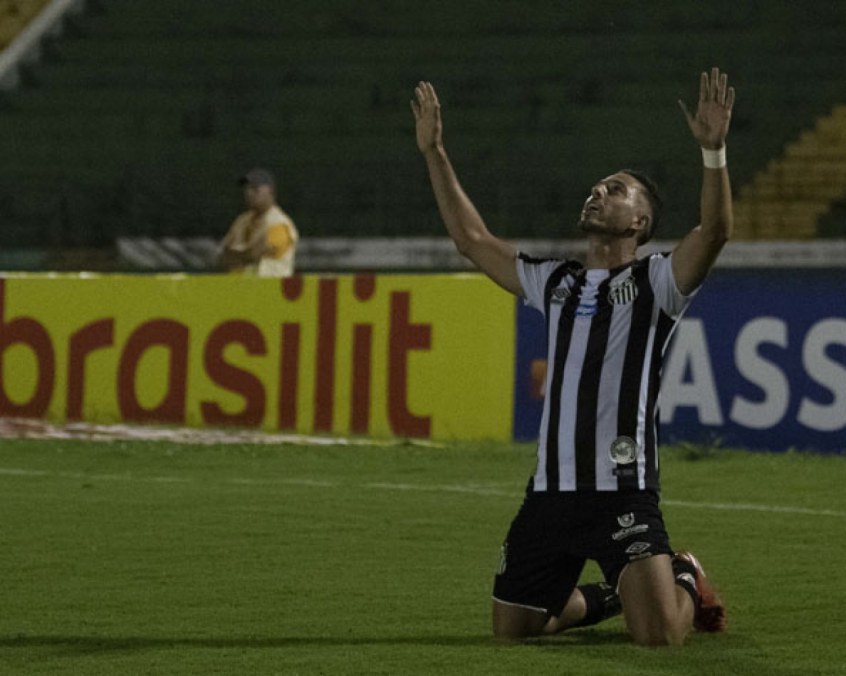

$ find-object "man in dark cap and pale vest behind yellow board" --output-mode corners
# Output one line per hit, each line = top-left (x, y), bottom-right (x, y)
(218, 168), (300, 277)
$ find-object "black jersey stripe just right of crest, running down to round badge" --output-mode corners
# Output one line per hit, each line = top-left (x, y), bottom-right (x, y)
(617, 258), (654, 490)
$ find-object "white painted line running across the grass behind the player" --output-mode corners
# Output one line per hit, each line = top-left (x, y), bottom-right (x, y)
(0, 467), (846, 519)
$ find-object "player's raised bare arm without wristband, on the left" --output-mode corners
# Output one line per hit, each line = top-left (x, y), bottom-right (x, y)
(411, 82), (523, 296)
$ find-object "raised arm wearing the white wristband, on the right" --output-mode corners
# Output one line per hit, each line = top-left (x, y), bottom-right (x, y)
(672, 68), (734, 294)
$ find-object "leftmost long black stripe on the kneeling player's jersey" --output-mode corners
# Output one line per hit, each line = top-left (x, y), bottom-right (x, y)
(544, 266), (587, 491)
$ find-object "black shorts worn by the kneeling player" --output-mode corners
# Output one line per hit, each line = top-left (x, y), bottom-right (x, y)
(493, 491), (672, 616)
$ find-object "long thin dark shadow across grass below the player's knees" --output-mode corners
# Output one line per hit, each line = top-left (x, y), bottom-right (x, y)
(0, 630), (629, 654)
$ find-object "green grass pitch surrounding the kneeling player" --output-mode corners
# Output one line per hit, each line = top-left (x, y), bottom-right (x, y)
(0, 440), (846, 676)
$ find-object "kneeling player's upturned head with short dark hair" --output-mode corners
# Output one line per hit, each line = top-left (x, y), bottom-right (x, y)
(579, 172), (649, 237)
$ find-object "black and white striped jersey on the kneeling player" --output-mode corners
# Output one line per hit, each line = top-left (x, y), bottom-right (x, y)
(517, 254), (693, 492)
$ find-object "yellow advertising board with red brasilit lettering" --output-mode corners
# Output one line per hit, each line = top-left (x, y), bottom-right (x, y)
(0, 275), (516, 440)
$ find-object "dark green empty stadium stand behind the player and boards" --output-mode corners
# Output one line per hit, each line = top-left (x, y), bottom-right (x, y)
(0, 0), (846, 262)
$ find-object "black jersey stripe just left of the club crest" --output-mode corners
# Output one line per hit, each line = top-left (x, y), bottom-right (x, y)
(575, 276), (613, 490)
